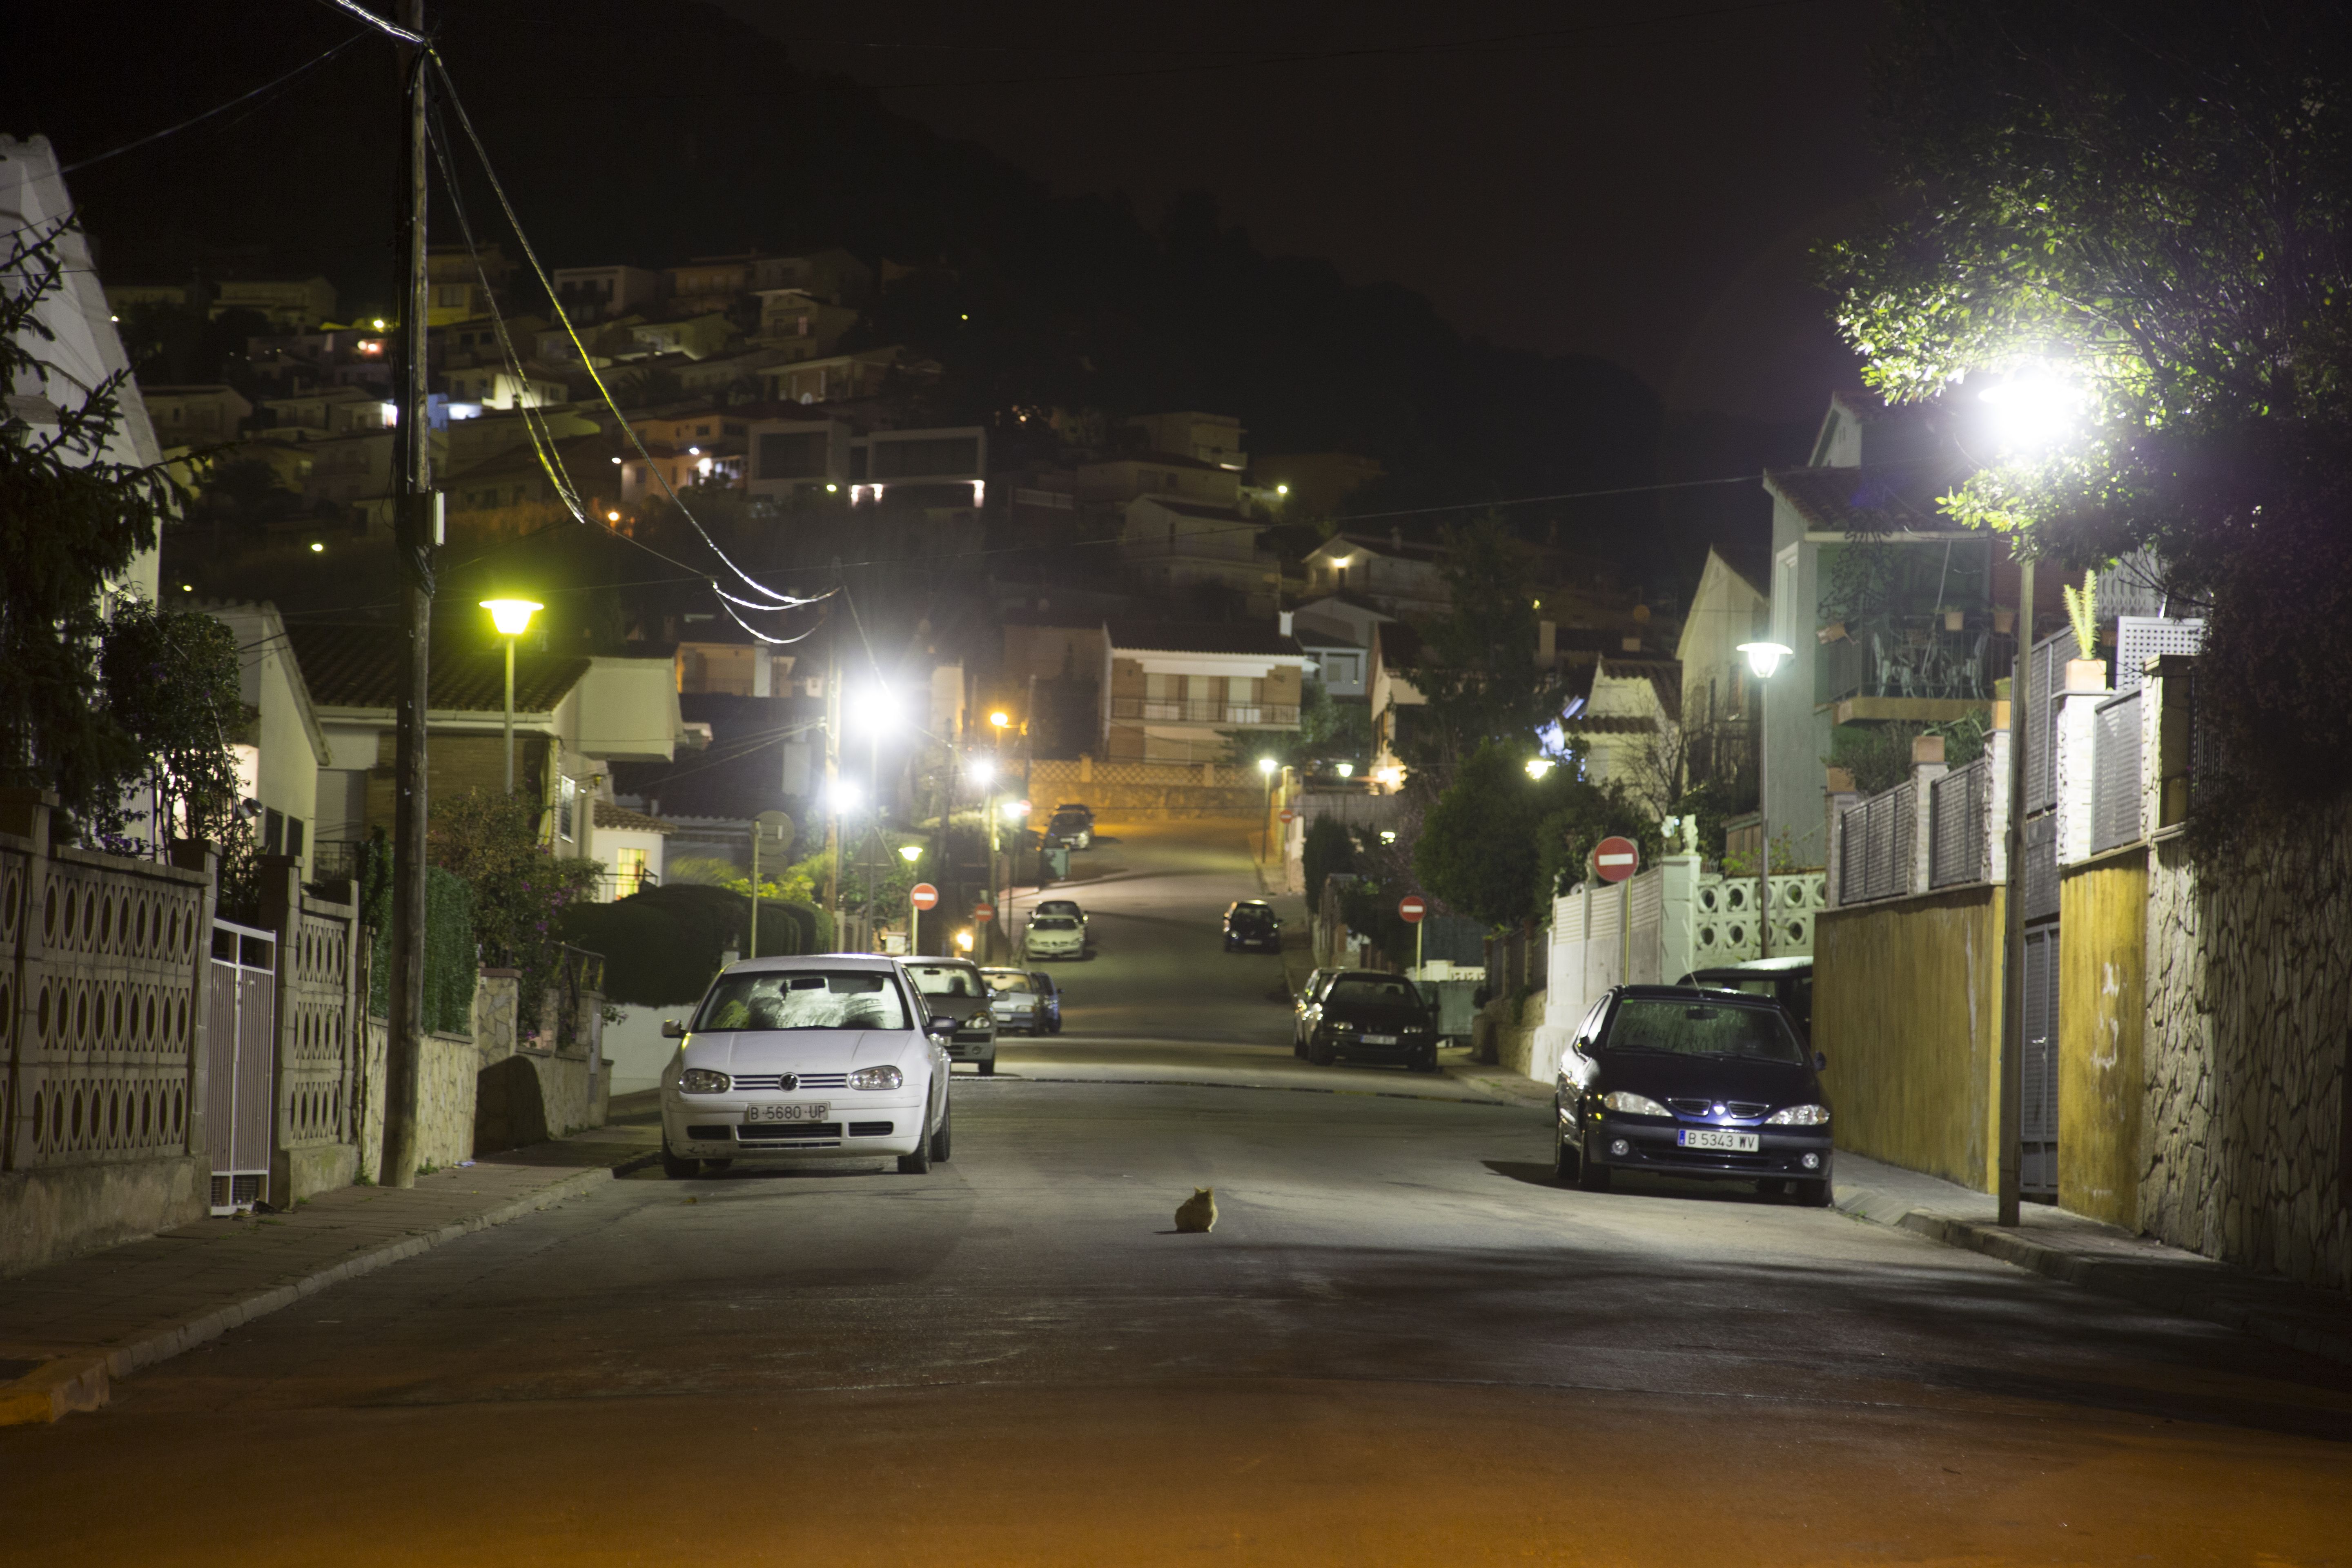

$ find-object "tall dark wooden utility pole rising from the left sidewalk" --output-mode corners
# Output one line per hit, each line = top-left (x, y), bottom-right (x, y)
(376, 0), (437, 1187)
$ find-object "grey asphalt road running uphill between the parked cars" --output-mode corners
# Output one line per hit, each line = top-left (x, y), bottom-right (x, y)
(13, 818), (2352, 1563)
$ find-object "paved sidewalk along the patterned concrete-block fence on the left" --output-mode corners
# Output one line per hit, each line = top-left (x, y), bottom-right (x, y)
(0, 1124), (661, 1427)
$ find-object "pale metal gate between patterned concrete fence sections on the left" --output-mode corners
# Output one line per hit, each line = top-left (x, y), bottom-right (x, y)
(205, 919), (278, 1213)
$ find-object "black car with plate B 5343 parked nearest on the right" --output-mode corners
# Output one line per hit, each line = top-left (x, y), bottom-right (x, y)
(1552, 985), (1830, 1208)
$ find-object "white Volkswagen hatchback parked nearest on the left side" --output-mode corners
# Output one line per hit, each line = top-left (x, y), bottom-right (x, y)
(661, 952), (955, 1178)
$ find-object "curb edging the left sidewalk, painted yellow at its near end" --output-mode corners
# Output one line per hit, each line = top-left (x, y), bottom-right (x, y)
(0, 1149), (661, 1427)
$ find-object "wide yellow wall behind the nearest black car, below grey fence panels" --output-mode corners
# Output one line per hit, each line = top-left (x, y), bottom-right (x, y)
(1813, 886), (2002, 1192)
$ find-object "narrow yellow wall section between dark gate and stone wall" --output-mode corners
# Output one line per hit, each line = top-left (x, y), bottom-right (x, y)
(2058, 844), (2147, 1229)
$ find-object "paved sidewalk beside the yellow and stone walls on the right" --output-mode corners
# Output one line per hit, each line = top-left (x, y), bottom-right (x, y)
(1837, 1149), (2352, 1361)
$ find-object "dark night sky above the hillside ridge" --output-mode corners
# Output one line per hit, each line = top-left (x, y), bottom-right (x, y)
(743, 0), (1877, 421)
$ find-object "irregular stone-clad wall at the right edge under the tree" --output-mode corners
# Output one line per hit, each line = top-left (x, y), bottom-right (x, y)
(2140, 799), (2352, 1291)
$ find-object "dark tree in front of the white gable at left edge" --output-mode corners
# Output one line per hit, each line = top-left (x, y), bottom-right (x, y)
(0, 223), (174, 820)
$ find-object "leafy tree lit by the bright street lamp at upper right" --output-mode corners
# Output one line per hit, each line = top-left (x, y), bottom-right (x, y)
(1825, 0), (2352, 799)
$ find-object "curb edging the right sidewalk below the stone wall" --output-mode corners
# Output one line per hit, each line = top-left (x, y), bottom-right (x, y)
(1837, 1192), (2352, 1363)
